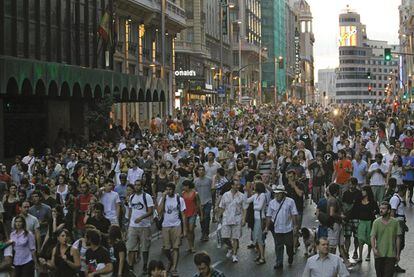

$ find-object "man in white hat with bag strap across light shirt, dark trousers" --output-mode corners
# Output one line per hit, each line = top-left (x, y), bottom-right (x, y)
(265, 185), (298, 269)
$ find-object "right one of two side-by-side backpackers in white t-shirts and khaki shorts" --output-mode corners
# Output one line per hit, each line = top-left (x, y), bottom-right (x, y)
(158, 183), (187, 276)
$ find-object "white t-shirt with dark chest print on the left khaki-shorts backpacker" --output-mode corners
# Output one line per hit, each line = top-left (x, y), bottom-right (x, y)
(129, 193), (154, 227)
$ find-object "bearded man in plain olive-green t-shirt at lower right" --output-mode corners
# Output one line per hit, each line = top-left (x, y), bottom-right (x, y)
(371, 201), (402, 277)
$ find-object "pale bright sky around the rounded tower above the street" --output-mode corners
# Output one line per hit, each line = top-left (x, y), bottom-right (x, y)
(307, 0), (401, 80)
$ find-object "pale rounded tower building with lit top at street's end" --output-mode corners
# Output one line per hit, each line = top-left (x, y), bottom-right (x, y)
(335, 8), (398, 104)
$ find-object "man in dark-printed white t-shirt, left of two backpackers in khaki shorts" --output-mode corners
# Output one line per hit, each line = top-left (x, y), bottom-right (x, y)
(126, 180), (154, 272)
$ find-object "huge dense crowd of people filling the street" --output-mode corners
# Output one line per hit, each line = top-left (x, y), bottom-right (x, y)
(0, 103), (414, 277)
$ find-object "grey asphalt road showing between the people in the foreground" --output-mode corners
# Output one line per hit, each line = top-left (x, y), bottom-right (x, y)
(136, 198), (414, 277)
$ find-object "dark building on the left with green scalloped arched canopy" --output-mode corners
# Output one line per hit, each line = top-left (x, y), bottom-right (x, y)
(0, 0), (185, 159)
